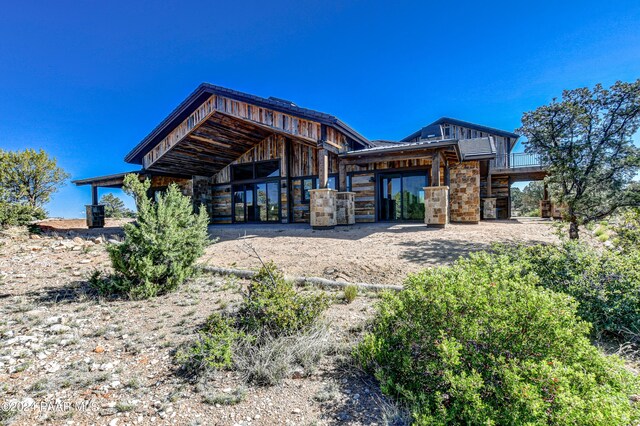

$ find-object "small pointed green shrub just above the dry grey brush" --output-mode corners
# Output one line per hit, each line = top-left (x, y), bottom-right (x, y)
(239, 262), (329, 336)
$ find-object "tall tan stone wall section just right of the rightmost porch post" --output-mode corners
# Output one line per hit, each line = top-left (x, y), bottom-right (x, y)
(449, 161), (480, 222)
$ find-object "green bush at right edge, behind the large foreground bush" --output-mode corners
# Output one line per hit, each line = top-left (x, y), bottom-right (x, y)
(497, 242), (640, 335)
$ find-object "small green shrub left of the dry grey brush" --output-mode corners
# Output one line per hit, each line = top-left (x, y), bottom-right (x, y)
(176, 313), (242, 374)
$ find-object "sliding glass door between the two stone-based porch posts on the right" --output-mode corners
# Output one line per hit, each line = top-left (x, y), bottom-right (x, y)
(378, 172), (428, 221)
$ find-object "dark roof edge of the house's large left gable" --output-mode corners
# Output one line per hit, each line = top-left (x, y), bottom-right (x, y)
(124, 83), (372, 164)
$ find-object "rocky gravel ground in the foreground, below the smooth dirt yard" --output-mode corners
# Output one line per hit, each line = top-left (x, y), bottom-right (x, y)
(0, 231), (393, 425)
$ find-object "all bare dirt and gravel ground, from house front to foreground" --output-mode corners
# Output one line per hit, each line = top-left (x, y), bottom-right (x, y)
(0, 221), (555, 426)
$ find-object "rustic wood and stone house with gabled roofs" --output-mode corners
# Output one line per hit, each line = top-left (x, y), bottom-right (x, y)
(74, 83), (544, 227)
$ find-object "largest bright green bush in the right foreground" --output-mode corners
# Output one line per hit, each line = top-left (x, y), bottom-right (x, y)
(354, 253), (640, 425)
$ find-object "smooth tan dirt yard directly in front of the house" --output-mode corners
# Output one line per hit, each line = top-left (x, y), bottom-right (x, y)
(202, 219), (557, 284)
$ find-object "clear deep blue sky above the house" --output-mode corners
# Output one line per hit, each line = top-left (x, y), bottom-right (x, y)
(0, 0), (640, 217)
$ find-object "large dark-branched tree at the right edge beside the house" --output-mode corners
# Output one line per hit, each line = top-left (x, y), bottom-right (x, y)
(517, 80), (640, 238)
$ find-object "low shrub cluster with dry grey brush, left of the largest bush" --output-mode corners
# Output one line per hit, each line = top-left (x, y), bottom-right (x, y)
(176, 263), (331, 386)
